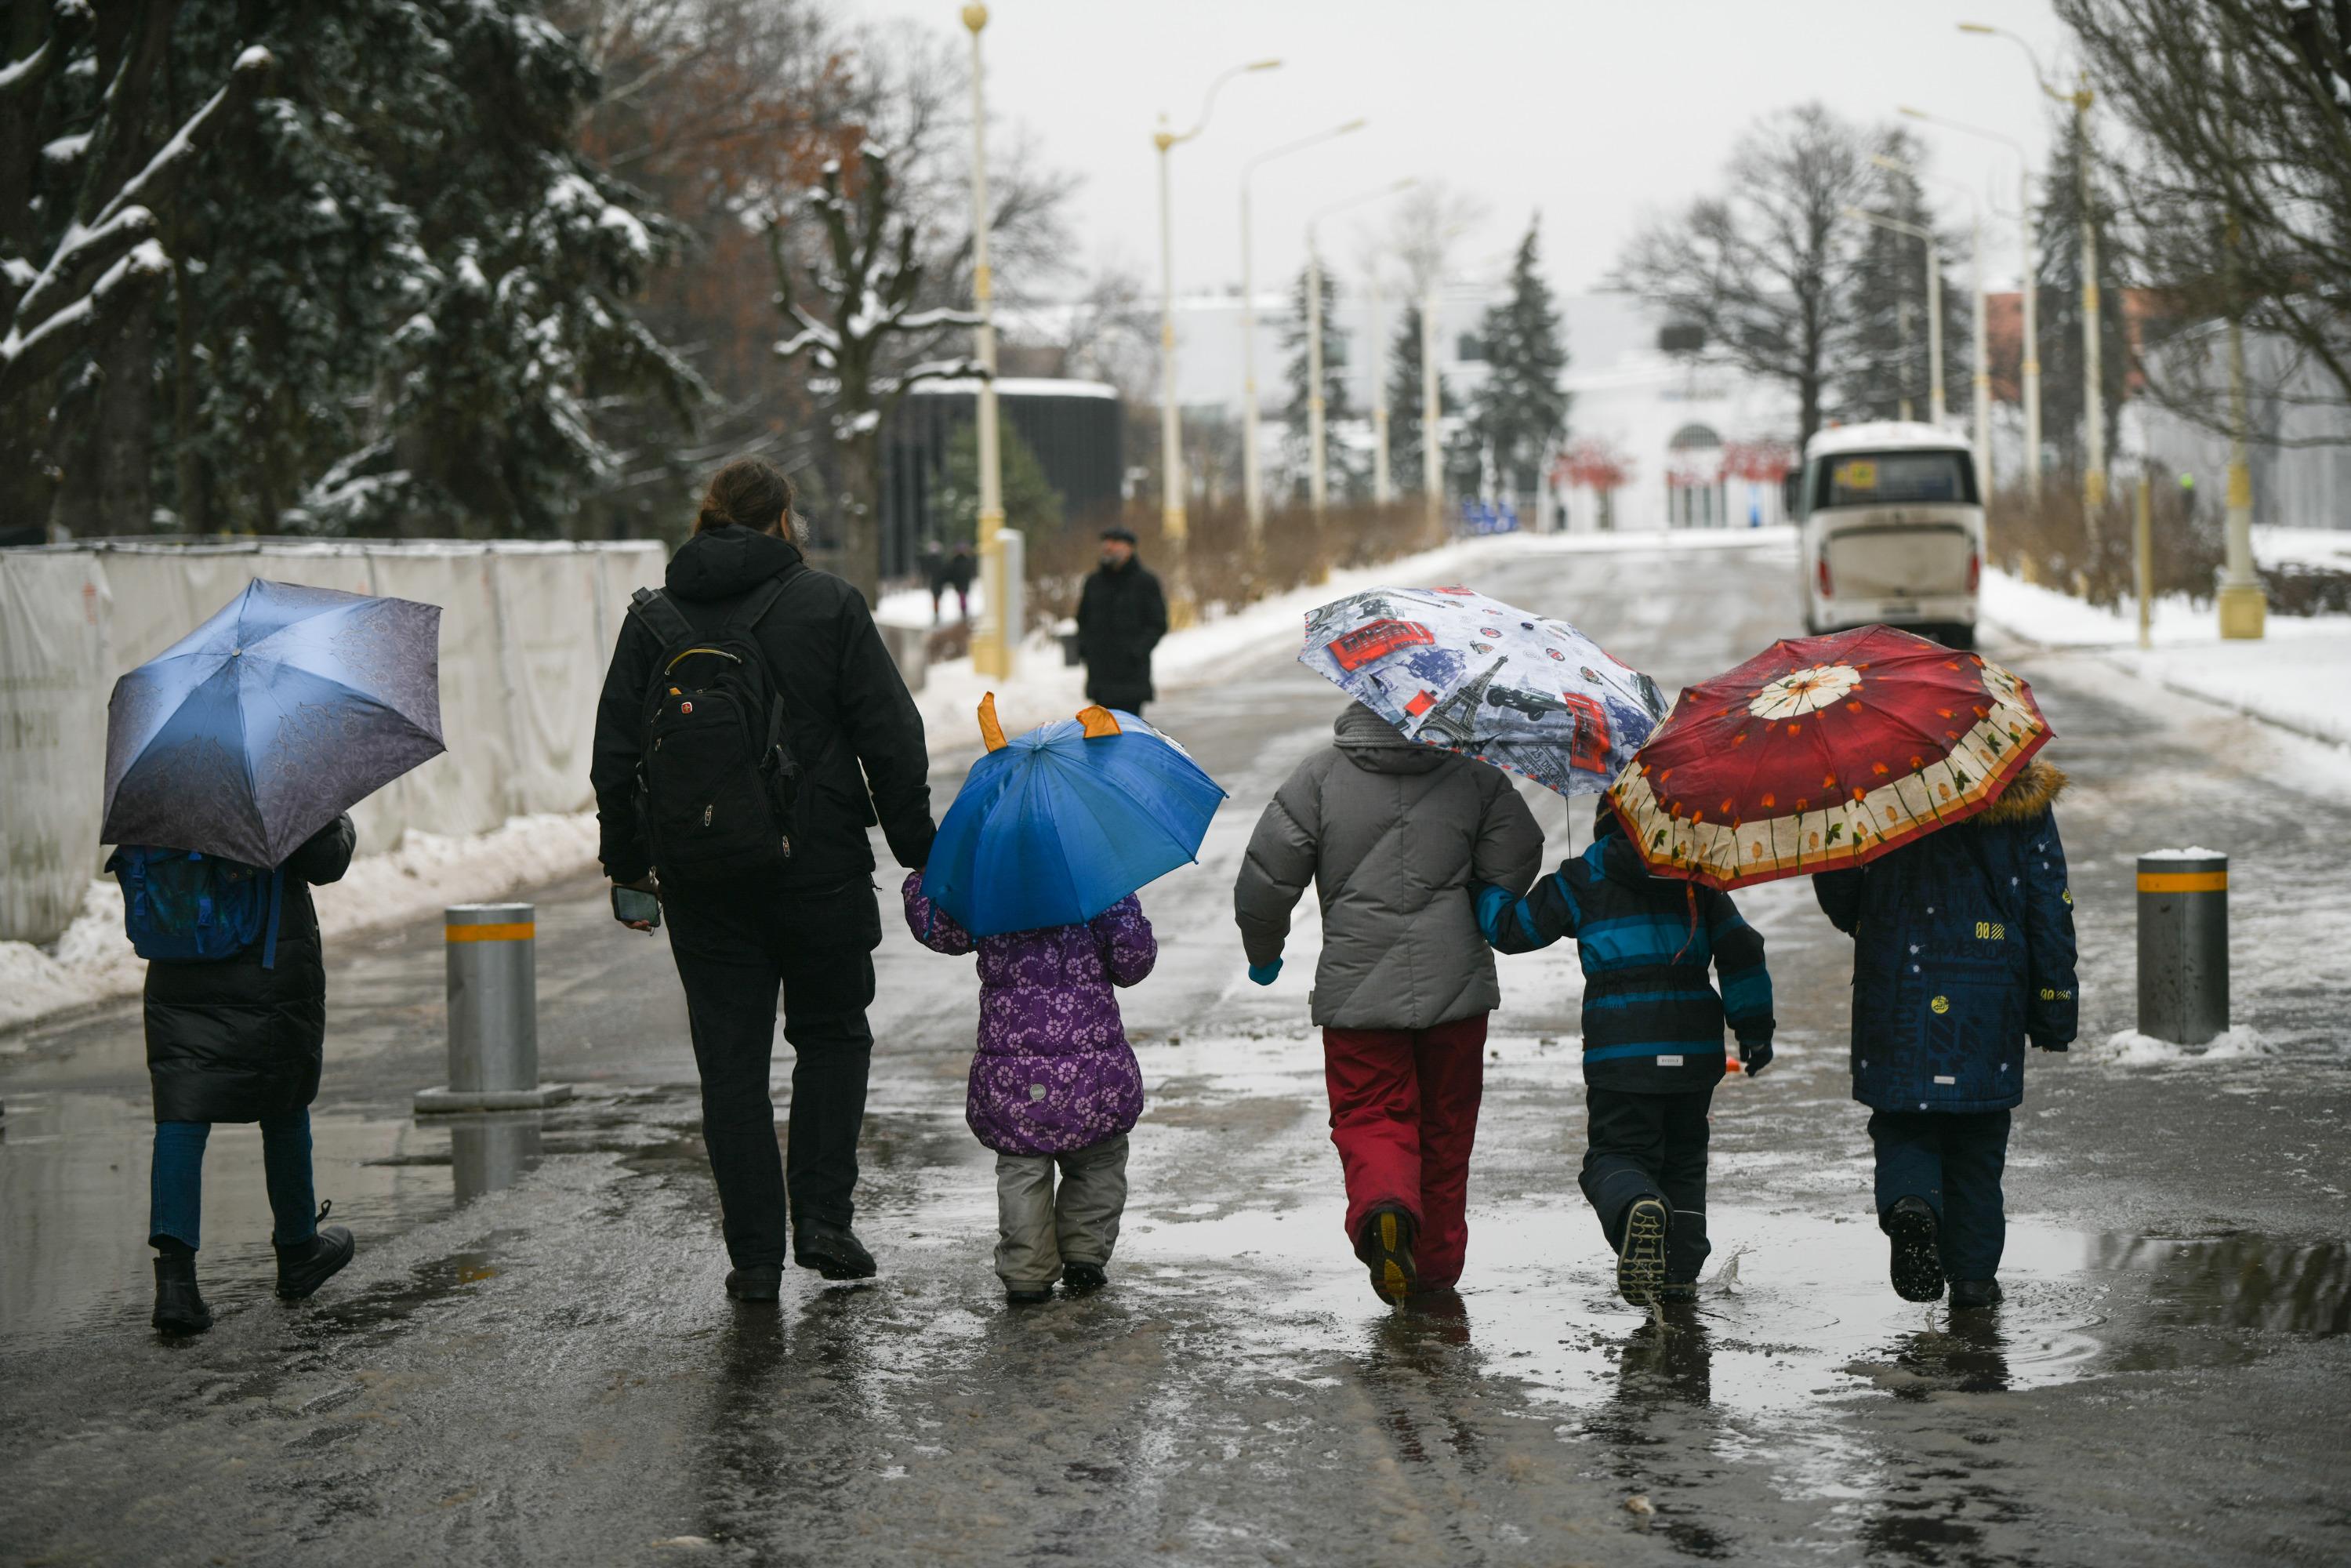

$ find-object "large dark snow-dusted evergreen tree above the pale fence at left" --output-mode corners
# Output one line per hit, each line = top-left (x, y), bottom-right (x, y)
(165, 0), (698, 534)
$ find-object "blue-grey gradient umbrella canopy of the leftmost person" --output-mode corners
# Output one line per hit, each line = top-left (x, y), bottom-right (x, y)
(101, 581), (444, 865)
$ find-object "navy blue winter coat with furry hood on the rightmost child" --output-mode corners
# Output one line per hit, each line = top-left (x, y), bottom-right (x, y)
(1812, 760), (2078, 1112)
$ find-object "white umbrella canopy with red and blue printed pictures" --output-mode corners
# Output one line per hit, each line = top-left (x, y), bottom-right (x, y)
(1297, 588), (1664, 794)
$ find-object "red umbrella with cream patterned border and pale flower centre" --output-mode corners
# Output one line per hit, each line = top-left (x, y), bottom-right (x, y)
(1608, 626), (2050, 888)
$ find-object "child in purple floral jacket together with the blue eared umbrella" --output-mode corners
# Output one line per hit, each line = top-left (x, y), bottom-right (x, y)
(903, 694), (1224, 1307)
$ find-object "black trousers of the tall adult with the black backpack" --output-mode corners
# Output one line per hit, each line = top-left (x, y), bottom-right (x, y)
(666, 881), (882, 1267)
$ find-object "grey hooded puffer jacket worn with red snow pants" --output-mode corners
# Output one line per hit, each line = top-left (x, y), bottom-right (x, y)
(1232, 703), (1542, 1029)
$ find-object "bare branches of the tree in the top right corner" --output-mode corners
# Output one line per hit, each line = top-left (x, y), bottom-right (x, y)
(2057, 0), (2351, 445)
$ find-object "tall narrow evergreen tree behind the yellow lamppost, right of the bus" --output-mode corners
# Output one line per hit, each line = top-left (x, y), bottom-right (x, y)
(2034, 115), (2130, 473)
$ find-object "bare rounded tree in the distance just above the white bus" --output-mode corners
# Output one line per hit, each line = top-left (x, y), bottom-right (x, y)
(1613, 103), (1871, 445)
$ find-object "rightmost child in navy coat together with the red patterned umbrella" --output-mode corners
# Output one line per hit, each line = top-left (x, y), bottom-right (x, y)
(1613, 626), (2076, 1309)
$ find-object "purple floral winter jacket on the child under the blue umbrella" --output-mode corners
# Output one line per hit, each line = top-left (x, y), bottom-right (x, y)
(905, 872), (1159, 1154)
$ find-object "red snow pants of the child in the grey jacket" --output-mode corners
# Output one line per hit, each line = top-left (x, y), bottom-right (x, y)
(1323, 1013), (1486, 1290)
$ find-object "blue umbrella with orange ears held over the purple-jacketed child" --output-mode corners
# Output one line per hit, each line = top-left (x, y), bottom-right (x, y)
(922, 696), (1224, 935)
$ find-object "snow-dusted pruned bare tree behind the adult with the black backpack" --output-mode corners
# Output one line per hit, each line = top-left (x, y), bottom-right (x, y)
(769, 143), (981, 602)
